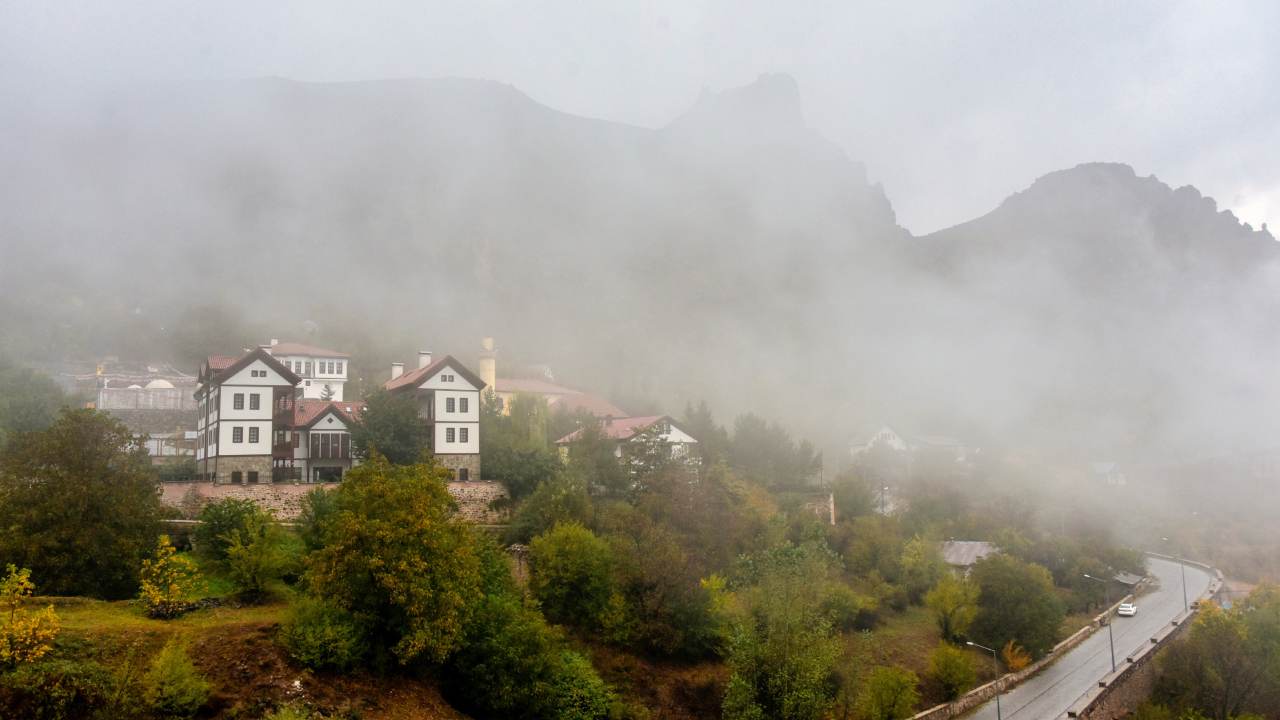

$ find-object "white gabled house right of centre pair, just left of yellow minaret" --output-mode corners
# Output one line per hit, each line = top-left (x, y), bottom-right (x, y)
(385, 351), (485, 480)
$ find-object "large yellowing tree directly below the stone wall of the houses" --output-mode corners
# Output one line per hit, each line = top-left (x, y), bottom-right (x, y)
(307, 455), (481, 664)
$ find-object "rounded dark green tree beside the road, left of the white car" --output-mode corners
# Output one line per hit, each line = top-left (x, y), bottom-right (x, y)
(970, 555), (1066, 657)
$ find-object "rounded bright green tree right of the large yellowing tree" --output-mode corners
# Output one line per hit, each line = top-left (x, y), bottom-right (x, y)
(529, 523), (613, 626)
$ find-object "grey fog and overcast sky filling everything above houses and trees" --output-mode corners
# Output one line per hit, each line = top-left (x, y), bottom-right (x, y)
(0, 3), (1280, 464)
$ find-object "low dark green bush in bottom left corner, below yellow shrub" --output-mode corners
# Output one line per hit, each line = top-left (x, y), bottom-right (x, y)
(0, 660), (120, 720)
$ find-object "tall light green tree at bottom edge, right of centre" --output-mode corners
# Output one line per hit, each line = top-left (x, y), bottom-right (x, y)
(723, 544), (840, 720)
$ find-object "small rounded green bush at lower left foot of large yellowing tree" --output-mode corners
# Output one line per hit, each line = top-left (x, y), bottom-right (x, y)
(279, 596), (367, 671)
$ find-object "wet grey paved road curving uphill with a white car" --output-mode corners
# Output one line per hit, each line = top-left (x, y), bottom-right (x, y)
(965, 557), (1210, 720)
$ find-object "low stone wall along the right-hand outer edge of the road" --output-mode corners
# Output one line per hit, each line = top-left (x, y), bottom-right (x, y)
(1062, 552), (1222, 720)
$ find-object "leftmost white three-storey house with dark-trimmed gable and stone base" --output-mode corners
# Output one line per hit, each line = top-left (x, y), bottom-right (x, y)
(196, 347), (302, 483)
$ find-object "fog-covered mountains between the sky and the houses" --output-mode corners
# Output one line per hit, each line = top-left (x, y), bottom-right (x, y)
(0, 76), (1277, 456)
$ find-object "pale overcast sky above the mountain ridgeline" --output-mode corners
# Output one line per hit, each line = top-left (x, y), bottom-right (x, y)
(0, 0), (1280, 234)
